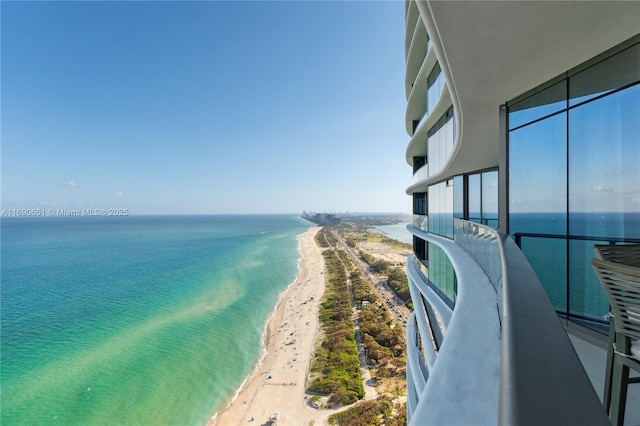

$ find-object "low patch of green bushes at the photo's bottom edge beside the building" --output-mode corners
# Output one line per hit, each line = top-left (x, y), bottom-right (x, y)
(329, 395), (407, 426)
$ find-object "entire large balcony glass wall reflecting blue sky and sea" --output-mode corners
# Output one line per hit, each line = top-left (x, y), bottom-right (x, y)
(510, 40), (640, 330)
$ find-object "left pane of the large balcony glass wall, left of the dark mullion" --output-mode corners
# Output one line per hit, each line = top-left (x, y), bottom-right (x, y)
(509, 114), (567, 311)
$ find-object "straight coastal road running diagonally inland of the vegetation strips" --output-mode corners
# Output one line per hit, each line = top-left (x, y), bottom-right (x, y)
(331, 231), (411, 331)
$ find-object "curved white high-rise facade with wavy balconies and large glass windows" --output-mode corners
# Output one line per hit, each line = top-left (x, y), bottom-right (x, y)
(405, 1), (640, 425)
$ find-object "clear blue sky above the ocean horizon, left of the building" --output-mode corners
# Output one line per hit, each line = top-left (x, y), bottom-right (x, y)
(1, 1), (411, 214)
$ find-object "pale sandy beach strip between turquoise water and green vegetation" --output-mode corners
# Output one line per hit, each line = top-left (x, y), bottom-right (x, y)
(209, 226), (337, 426)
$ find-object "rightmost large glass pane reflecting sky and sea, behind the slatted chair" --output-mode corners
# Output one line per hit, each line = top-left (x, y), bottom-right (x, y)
(569, 85), (640, 320)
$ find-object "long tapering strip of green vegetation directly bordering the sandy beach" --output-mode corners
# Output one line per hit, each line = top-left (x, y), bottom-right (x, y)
(309, 229), (364, 405)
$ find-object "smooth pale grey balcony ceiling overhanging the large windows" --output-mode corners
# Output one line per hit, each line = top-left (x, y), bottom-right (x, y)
(418, 1), (640, 180)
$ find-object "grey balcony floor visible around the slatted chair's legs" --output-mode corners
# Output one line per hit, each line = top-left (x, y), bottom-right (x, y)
(562, 320), (640, 426)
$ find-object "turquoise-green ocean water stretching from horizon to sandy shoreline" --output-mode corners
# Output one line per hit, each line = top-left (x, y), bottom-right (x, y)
(0, 215), (308, 425)
